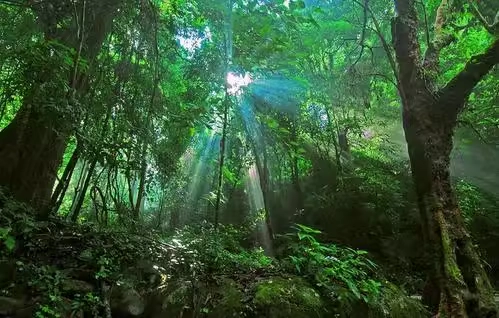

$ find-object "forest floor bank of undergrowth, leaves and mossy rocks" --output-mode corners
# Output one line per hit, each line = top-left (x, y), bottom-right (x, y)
(0, 214), (426, 318)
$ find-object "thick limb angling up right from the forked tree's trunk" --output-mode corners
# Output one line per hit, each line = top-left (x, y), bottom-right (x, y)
(438, 39), (499, 113)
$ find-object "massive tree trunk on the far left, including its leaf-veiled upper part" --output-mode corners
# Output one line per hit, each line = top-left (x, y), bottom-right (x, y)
(0, 0), (121, 218)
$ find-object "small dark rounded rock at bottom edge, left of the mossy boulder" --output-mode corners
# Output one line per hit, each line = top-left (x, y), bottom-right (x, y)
(111, 285), (145, 317)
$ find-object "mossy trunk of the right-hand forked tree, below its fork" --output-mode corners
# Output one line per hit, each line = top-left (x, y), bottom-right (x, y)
(404, 90), (495, 318)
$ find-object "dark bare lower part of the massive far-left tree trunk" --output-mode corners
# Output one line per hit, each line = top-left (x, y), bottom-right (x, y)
(0, 102), (69, 217)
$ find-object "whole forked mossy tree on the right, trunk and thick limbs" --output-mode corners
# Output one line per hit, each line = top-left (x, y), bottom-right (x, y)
(392, 0), (499, 317)
